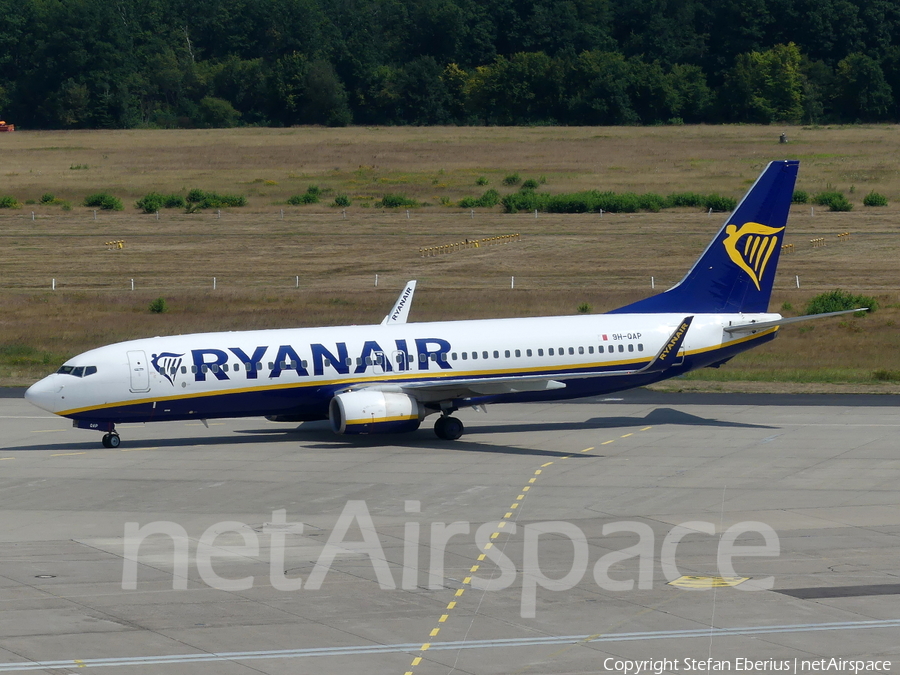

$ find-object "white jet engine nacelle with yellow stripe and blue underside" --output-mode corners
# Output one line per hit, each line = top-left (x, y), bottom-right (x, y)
(328, 390), (425, 434)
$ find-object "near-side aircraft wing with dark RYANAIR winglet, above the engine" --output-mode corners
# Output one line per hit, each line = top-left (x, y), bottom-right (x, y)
(348, 316), (694, 400)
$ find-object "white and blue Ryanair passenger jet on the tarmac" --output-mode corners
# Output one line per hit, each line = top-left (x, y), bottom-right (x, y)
(25, 160), (860, 447)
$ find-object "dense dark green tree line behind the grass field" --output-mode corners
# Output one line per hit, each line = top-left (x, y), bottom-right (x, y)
(0, 0), (900, 128)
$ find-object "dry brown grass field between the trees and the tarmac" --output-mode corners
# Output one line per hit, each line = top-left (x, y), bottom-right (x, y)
(0, 126), (900, 392)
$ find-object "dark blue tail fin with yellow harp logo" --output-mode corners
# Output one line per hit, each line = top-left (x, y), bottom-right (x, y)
(610, 160), (800, 314)
